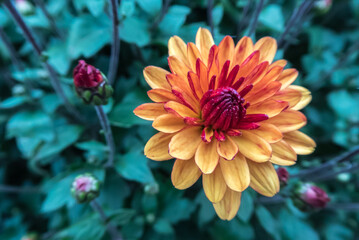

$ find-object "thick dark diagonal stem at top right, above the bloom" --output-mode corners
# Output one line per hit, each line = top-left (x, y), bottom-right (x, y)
(278, 0), (314, 48)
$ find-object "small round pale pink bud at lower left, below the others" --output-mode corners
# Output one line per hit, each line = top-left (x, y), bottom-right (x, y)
(71, 173), (100, 203)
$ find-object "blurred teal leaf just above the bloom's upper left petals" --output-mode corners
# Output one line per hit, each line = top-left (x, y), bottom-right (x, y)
(158, 5), (191, 35)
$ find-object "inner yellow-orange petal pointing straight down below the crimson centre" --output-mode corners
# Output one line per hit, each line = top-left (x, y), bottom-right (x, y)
(195, 139), (219, 174)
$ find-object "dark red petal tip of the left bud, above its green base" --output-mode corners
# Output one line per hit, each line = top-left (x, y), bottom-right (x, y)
(73, 60), (104, 88)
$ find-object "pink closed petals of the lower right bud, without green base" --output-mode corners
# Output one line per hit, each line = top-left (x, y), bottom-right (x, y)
(300, 183), (330, 208)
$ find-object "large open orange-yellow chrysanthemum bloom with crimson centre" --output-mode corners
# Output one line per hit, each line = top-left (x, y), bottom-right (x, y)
(134, 28), (315, 220)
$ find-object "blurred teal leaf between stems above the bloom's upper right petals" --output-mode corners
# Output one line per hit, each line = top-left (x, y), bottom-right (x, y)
(259, 4), (284, 32)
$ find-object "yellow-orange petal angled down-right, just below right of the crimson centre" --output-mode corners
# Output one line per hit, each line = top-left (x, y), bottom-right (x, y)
(232, 130), (272, 162)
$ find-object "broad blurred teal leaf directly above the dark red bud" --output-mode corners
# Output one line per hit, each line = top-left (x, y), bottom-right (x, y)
(67, 15), (112, 59)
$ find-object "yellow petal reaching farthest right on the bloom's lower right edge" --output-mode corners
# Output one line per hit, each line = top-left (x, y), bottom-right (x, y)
(284, 131), (317, 155)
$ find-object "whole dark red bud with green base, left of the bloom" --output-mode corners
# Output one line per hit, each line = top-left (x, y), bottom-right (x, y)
(73, 60), (113, 105)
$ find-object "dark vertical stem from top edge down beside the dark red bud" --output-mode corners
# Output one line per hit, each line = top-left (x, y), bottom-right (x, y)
(107, 0), (120, 84)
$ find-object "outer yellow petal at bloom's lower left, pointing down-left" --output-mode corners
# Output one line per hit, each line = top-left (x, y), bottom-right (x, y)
(171, 159), (202, 190)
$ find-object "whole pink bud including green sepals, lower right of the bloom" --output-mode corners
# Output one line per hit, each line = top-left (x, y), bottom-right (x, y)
(294, 183), (330, 211)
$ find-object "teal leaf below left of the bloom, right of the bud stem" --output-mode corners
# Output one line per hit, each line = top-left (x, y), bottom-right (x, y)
(115, 151), (154, 183)
